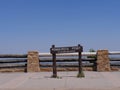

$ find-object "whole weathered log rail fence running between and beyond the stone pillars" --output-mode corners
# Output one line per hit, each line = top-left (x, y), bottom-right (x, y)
(0, 51), (120, 71)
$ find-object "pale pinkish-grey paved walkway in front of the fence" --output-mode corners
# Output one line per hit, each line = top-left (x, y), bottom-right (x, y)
(0, 71), (120, 90)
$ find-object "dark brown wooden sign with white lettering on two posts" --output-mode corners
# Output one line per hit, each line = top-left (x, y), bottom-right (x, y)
(50, 44), (84, 78)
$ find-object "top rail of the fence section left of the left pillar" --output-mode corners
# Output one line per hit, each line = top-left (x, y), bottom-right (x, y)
(0, 54), (27, 58)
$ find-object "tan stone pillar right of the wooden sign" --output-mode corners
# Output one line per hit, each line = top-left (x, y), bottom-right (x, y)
(97, 50), (111, 72)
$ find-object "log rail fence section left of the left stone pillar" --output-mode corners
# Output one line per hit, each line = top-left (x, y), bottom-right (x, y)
(0, 54), (27, 72)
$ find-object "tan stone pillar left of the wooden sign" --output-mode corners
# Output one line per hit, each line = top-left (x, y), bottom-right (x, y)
(27, 51), (40, 72)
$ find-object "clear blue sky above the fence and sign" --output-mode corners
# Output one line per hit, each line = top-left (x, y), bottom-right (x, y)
(0, 0), (120, 54)
